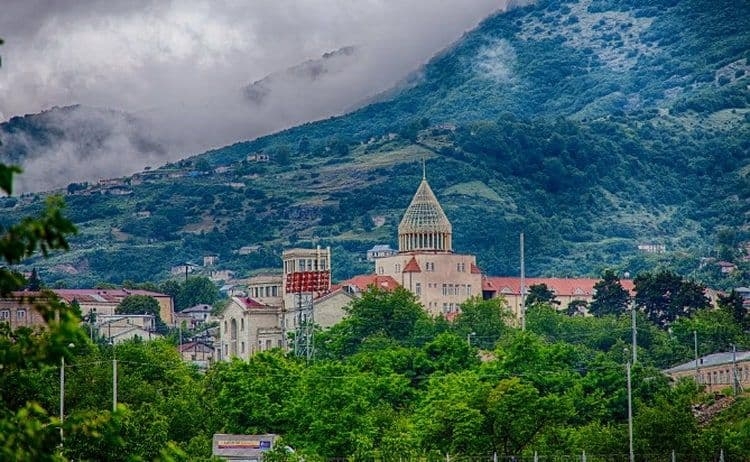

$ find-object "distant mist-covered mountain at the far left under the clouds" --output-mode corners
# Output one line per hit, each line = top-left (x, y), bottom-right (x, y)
(0, 105), (167, 192)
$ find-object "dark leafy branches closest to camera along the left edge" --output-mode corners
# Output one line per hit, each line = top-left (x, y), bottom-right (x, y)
(0, 123), (120, 461)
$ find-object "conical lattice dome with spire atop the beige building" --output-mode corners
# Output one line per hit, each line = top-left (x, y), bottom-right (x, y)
(398, 177), (453, 252)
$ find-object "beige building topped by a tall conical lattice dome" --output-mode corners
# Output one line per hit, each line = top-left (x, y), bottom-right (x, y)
(375, 171), (482, 317)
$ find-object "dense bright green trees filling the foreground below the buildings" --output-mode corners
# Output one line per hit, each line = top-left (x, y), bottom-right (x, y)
(0, 290), (750, 460)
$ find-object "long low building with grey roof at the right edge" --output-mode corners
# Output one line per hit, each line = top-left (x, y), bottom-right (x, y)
(663, 351), (750, 392)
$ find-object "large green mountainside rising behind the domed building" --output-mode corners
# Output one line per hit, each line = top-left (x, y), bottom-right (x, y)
(0, 0), (750, 285)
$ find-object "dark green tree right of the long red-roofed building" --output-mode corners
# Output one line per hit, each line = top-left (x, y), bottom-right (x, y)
(633, 270), (710, 329)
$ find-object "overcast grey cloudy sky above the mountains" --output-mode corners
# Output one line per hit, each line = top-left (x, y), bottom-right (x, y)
(0, 0), (505, 158)
